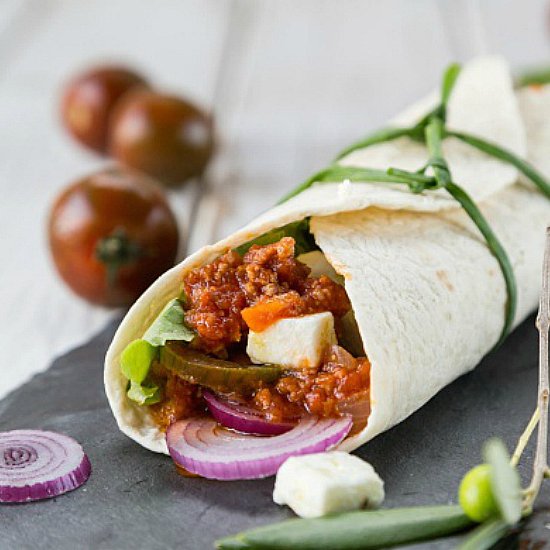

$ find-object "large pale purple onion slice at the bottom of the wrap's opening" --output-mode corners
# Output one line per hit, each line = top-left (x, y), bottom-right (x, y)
(166, 416), (353, 480)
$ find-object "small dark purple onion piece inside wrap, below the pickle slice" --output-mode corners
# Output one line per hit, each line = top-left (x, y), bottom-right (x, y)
(204, 392), (295, 435)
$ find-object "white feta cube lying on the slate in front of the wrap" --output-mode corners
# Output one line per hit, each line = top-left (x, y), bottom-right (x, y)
(273, 451), (384, 518)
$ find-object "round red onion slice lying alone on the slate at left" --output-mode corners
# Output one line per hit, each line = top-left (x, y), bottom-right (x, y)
(0, 430), (92, 502)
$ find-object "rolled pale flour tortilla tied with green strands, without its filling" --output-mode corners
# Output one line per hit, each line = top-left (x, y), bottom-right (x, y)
(105, 57), (550, 453)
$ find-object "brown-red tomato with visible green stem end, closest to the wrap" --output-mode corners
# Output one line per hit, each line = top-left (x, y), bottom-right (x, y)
(49, 168), (178, 306)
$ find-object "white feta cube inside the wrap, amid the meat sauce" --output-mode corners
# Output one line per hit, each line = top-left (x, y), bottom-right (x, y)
(246, 311), (337, 369)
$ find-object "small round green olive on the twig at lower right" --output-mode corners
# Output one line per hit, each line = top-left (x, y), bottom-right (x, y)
(458, 464), (498, 523)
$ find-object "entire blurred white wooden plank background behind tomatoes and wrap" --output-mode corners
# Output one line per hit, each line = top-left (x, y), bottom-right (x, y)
(0, 0), (550, 402)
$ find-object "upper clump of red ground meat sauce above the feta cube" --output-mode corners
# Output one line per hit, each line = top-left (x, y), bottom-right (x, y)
(183, 237), (351, 355)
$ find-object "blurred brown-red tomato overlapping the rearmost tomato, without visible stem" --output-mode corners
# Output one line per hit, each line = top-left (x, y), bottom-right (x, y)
(109, 91), (214, 186)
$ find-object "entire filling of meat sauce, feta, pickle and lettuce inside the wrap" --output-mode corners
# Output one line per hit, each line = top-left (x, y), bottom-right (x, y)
(121, 236), (370, 435)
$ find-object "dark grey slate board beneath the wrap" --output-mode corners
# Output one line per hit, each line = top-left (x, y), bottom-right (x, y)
(0, 318), (550, 550)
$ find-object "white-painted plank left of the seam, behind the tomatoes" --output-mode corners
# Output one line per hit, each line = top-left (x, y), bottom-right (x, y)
(0, 0), (228, 402)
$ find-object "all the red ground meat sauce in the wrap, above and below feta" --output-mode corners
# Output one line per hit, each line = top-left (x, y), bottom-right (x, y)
(150, 238), (370, 429)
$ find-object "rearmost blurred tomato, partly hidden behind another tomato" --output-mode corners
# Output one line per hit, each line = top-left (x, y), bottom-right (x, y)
(61, 66), (147, 153)
